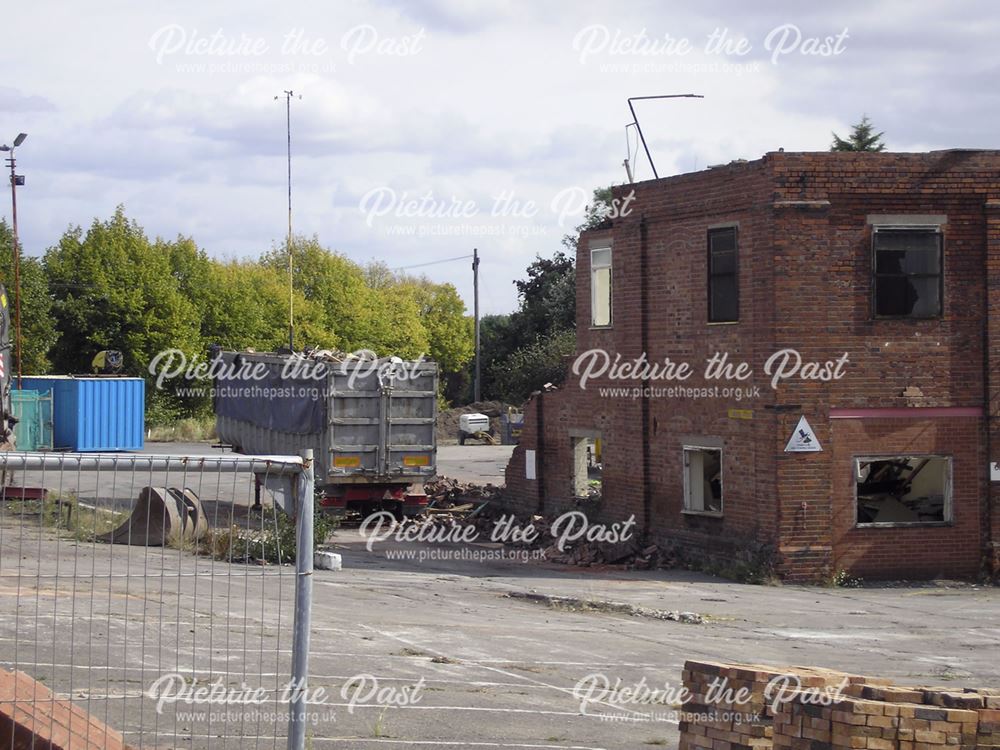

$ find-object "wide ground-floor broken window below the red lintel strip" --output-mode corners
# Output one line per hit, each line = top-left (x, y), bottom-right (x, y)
(854, 456), (951, 526)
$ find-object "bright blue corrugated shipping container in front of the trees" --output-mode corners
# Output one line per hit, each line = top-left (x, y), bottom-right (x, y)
(24, 375), (146, 452)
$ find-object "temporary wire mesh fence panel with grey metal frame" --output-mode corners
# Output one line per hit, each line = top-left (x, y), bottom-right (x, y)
(0, 452), (313, 750)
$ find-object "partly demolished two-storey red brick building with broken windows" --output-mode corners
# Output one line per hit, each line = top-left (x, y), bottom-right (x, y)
(507, 150), (1000, 579)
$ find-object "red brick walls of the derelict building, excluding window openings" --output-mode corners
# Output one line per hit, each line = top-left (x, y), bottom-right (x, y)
(508, 152), (1000, 578)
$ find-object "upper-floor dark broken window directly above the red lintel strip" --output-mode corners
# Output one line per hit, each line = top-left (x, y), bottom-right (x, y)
(873, 227), (942, 318)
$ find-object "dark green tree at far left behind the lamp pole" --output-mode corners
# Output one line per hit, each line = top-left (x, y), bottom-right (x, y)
(0, 221), (57, 375)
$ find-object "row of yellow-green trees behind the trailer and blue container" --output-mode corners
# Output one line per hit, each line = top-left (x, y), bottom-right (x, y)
(26, 207), (472, 425)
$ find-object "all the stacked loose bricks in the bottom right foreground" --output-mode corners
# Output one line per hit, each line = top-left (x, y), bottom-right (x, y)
(680, 661), (1000, 750)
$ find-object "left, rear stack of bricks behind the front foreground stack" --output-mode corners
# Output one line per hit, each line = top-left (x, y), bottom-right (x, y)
(679, 661), (860, 750)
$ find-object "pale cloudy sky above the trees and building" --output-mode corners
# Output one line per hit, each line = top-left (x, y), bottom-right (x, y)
(0, 0), (1000, 312)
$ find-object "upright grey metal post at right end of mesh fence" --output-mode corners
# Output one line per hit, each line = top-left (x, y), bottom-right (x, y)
(288, 449), (314, 750)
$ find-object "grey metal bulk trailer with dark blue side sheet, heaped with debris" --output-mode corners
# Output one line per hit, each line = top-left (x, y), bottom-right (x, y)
(214, 351), (438, 515)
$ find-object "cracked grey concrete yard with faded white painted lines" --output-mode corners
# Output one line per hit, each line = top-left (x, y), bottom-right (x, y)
(0, 446), (1000, 750)
